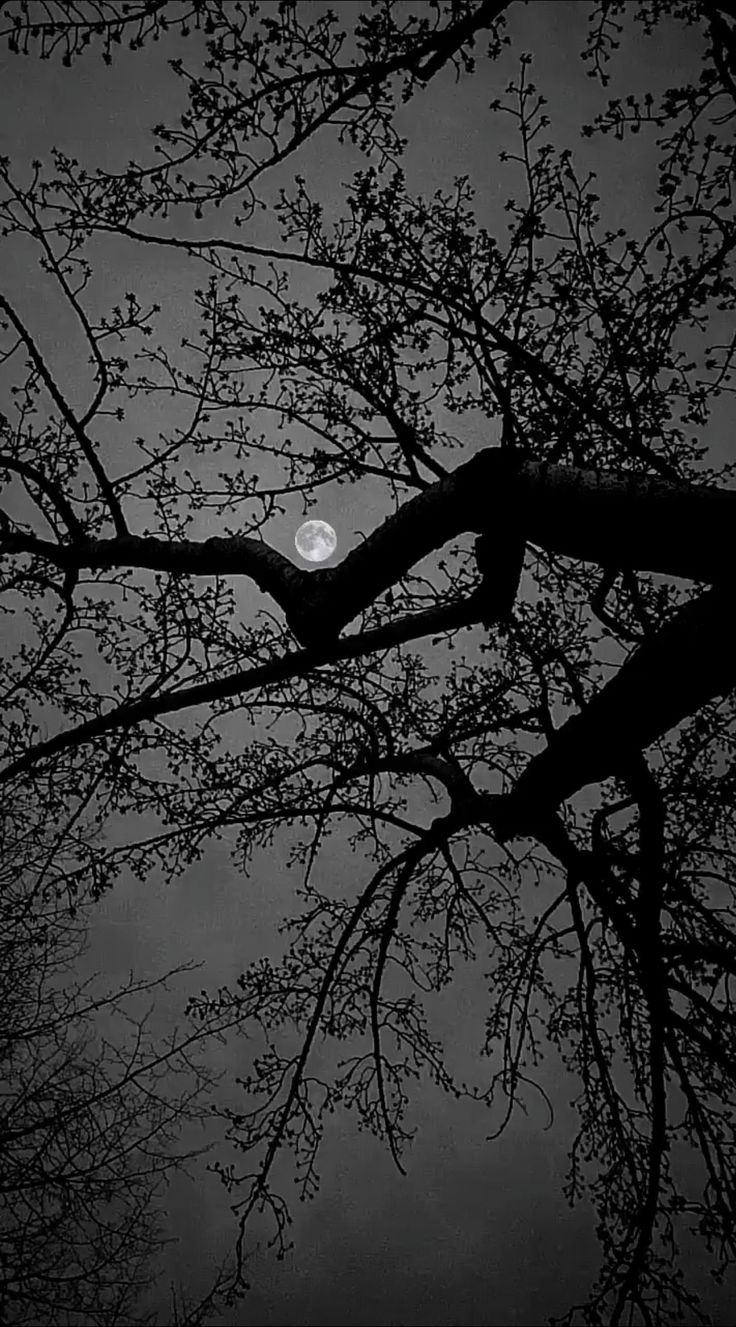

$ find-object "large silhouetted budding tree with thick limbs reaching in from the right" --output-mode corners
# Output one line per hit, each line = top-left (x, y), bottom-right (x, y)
(0, 0), (736, 1324)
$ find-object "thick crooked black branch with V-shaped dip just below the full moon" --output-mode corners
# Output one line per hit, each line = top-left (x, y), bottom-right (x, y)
(3, 447), (736, 646)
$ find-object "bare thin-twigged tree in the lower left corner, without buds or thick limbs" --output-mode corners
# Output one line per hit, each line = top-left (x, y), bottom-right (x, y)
(0, 812), (234, 1327)
